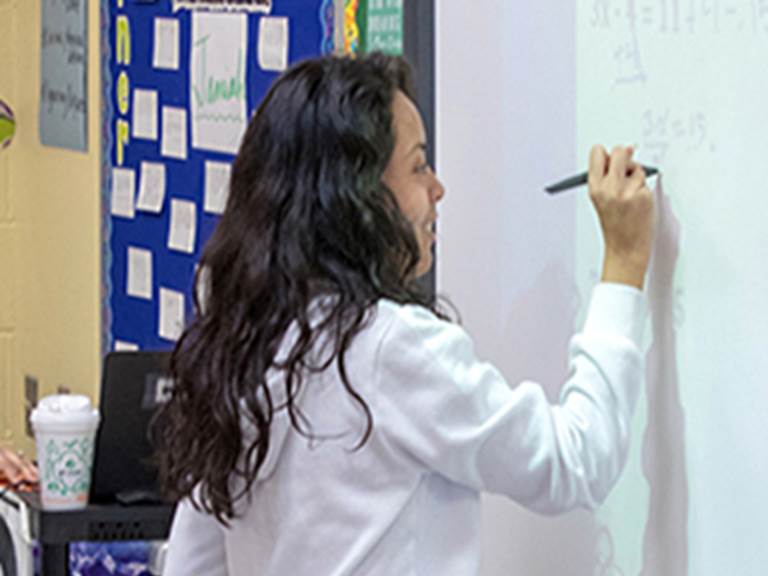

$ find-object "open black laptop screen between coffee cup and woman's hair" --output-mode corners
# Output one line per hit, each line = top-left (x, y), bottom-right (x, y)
(91, 351), (171, 505)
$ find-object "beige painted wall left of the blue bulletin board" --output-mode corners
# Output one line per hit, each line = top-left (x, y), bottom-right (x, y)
(0, 0), (101, 453)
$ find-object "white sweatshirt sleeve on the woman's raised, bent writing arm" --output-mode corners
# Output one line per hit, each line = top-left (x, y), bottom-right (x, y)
(376, 284), (647, 514)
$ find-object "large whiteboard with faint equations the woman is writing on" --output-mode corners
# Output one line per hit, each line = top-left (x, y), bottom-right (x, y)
(436, 0), (768, 576)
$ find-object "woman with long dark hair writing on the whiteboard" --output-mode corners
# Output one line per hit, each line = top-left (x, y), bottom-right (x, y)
(160, 55), (653, 576)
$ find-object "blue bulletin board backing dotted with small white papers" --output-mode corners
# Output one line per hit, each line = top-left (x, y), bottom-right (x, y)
(101, 0), (334, 352)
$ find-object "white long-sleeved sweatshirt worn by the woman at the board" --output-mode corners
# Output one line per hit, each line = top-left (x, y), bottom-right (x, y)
(164, 284), (646, 576)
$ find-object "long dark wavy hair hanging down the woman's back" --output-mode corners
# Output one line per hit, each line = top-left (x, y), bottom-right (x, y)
(154, 54), (437, 524)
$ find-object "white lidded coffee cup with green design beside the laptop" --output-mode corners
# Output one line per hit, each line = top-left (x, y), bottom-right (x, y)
(30, 394), (99, 510)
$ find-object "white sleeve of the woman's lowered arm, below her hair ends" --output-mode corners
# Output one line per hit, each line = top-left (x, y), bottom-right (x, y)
(163, 499), (228, 576)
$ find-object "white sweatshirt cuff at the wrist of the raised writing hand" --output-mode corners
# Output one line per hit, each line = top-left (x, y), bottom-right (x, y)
(583, 282), (648, 347)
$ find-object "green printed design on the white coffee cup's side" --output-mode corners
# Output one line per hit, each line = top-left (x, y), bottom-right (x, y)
(43, 438), (93, 498)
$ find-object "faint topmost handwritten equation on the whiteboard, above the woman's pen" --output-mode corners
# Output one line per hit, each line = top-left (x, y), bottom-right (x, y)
(589, 0), (768, 84)
